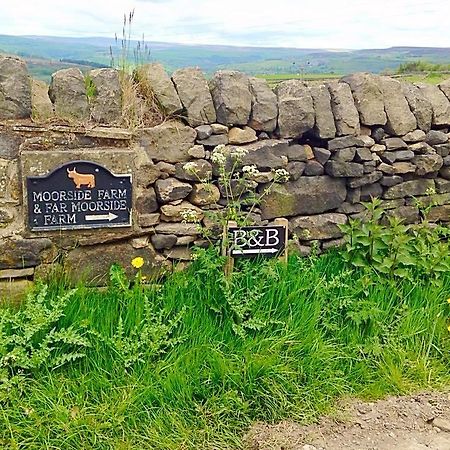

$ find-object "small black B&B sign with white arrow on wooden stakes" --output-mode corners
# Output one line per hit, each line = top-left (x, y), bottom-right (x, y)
(222, 219), (288, 276)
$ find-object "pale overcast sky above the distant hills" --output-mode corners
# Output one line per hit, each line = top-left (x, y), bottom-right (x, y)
(0, 0), (450, 48)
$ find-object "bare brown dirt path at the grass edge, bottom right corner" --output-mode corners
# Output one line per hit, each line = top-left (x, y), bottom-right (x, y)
(246, 393), (450, 450)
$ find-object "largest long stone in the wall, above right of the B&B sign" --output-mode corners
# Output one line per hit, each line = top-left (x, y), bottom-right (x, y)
(261, 176), (347, 220)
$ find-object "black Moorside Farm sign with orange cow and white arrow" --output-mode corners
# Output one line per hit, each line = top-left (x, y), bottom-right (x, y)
(27, 161), (132, 231)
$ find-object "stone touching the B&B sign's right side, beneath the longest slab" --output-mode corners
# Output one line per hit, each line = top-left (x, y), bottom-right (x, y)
(289, 213), (347, 241)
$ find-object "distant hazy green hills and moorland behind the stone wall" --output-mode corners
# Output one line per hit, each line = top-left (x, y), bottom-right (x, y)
(0, 35), (450, 81)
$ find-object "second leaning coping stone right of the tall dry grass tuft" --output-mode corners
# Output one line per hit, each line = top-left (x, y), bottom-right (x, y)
(172, 67), (216, 127)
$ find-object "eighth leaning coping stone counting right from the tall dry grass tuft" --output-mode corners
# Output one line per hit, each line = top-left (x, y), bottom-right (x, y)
(341, 73), (386, 125)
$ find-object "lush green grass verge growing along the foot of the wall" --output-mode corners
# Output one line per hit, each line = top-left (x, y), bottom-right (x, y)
(0, 246), (450, 449)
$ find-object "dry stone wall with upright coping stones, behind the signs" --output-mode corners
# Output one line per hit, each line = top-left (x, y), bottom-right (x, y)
(0, 53), (450, 283)
